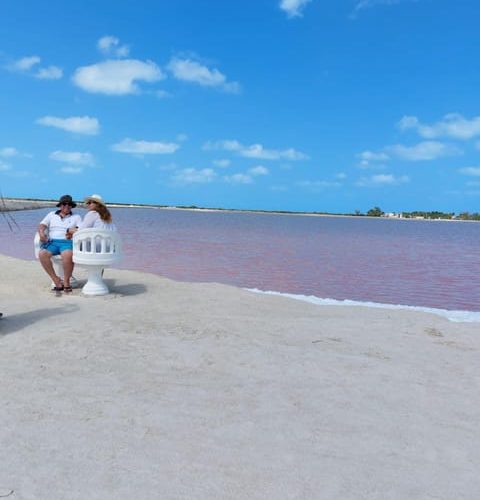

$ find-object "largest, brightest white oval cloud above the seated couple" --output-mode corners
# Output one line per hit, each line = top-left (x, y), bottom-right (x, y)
(72, 59), (165, 95)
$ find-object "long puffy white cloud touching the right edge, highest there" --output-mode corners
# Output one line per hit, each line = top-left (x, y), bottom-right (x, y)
(398, 113), (480, 140)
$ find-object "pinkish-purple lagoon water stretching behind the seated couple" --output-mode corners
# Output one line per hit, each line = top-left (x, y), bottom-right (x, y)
(0, 208), (480, 311)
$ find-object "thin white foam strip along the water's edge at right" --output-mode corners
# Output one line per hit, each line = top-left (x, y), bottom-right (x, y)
(245, 288), (480, 323)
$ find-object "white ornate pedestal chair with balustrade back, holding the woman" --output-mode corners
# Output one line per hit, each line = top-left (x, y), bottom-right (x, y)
(73, 228), (122, 295)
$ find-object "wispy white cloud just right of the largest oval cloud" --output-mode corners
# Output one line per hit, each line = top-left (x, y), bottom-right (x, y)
(167, 57), (240, 93)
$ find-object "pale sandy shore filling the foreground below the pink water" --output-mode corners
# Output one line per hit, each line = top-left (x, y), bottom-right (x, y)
(0, 256), (480, 500)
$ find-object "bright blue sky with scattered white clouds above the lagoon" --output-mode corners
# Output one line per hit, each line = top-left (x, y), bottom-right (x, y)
(0, 0), (480, 213)
